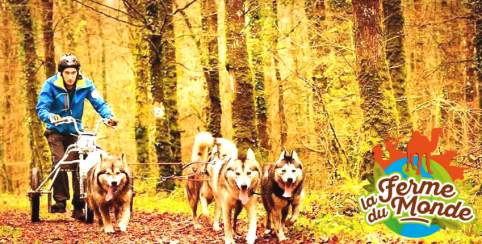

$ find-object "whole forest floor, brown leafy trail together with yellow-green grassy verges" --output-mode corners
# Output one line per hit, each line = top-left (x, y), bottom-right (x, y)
(0, 181), (482, 244)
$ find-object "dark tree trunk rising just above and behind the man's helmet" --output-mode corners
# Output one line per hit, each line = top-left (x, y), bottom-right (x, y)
(42, 0), (57, 78)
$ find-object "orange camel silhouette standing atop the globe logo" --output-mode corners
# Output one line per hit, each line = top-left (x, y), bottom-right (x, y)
(405, 128), (442, 175)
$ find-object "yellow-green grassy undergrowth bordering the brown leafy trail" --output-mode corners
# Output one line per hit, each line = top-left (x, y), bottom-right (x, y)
(0, 176), (482, 243)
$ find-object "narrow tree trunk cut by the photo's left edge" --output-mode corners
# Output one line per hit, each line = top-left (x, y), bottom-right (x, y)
(0, 9), (13, 192)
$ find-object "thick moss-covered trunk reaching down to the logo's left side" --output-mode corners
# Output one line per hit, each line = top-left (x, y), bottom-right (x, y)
(353, 0), (398, 177)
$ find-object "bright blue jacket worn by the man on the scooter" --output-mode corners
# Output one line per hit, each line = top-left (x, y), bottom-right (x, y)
(37, 73), (114, 135)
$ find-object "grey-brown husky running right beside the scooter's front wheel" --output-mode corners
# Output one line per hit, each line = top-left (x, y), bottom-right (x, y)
(85, 153), (134, 233)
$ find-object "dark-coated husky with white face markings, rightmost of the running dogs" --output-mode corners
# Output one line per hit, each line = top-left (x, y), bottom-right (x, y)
(261, 151), (305, 241)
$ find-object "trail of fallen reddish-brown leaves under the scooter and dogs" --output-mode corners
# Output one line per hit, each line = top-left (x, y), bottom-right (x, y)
(0, 210), (324, 244)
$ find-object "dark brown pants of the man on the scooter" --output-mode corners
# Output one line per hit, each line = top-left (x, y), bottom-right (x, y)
(44, 129), (84, 208)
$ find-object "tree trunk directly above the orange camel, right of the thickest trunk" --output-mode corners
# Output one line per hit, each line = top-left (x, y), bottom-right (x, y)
(383, 0), (413, 141)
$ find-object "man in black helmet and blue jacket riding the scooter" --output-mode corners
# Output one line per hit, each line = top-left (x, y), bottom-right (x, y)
(37, 54), (118, 219)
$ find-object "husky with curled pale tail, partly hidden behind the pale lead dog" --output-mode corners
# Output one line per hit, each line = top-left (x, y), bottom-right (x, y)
(185, 132), (237, 230)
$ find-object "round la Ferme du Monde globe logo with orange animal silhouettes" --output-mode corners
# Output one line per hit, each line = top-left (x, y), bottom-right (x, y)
(358, 128), (476, 238)
